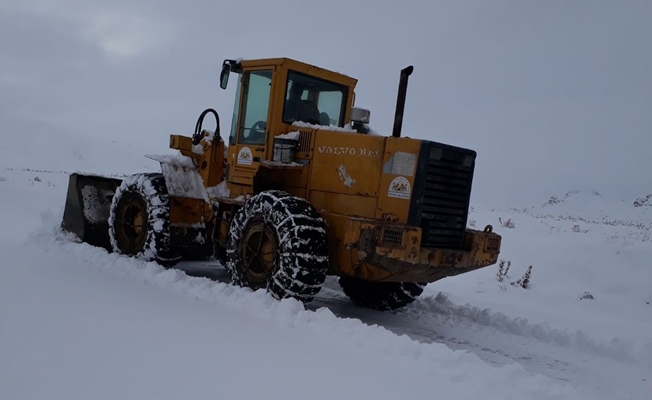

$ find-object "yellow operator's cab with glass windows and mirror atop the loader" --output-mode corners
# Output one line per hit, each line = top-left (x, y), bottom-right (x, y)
(220, 58), (357, 194)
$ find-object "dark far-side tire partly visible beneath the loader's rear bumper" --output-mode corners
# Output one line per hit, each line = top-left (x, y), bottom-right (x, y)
(339, 276), (426, 311)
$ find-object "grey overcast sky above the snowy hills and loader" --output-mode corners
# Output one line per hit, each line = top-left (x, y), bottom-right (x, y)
(0, 0), (652, 203)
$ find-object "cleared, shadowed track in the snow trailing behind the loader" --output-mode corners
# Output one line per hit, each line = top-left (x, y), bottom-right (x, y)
(310, 279), (652, 399)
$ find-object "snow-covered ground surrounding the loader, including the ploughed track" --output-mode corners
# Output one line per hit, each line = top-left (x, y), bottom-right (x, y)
(0, 117), (652, 400)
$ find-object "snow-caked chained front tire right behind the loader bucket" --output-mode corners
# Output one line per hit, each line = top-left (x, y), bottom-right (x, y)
(109, 173), (180, 267)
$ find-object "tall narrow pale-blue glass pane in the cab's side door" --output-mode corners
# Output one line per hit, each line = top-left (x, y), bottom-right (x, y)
(238, 70), (272, 145)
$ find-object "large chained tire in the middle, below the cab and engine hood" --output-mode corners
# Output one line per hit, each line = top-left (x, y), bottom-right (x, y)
(226, 190), (329, 303)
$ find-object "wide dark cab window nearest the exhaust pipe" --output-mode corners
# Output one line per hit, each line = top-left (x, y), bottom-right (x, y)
(283, 71), (348, 127)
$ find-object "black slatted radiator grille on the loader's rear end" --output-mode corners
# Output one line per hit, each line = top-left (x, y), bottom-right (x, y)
(420, 142), (476, 249)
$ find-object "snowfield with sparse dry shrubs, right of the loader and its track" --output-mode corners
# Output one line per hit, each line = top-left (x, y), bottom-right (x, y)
(438, 203), (652, 365)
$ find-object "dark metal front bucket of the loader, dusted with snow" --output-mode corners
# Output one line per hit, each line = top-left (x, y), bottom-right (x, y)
(61, 173), (122, 251)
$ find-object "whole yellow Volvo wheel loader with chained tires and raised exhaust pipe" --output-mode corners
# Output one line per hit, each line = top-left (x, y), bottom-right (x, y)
(62, 58), (501, 310)
